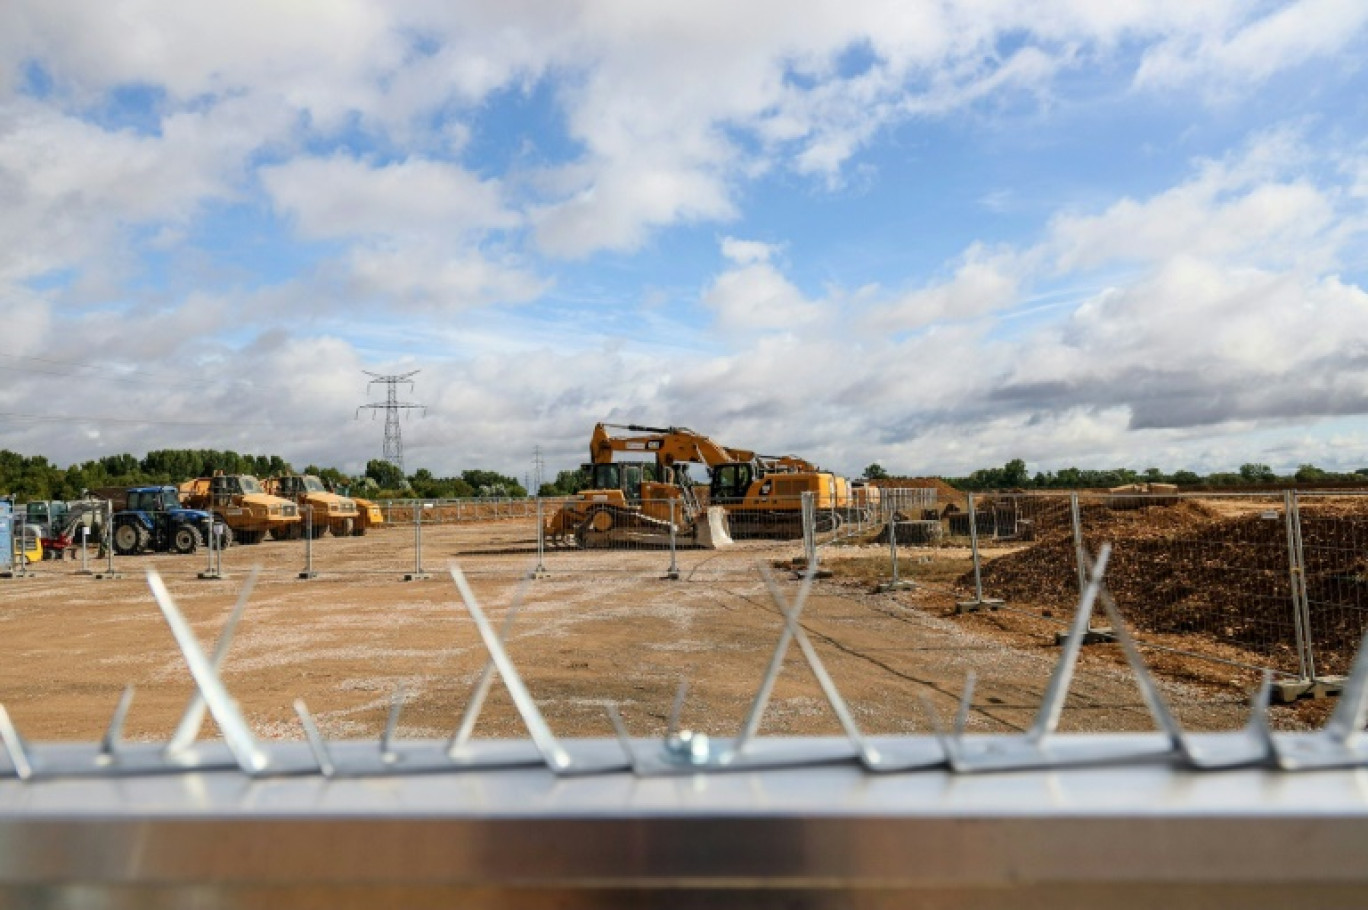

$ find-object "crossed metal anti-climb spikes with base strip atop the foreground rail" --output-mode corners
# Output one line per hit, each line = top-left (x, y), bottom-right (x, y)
(0, 546), (1368, 781)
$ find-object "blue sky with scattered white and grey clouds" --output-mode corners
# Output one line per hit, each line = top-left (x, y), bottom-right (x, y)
(0, 0), (1368, 479)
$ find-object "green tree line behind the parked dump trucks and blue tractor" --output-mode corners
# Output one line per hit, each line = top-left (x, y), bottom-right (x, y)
(0, 449), (527, 501)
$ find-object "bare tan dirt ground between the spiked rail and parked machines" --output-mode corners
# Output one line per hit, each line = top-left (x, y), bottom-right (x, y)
(0, 520), (1315, 740)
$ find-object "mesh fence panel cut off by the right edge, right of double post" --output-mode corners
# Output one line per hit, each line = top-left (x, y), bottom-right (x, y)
(1295, 493), (1368, 676)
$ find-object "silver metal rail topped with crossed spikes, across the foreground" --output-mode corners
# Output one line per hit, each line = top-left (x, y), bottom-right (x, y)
(0, 546), (1368, 907)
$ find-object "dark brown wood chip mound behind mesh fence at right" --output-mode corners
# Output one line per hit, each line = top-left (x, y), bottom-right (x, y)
(962, 499), (1368, 672)
